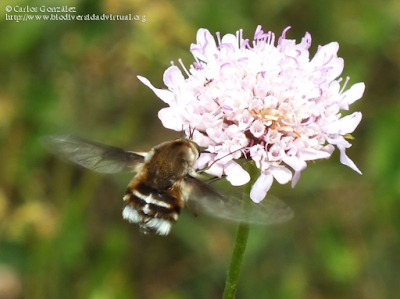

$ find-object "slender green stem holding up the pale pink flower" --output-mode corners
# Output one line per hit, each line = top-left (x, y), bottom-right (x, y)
(222, 167), (254, 299)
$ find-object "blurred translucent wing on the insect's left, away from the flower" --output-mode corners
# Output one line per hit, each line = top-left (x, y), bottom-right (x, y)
(40, 135), (144, 173)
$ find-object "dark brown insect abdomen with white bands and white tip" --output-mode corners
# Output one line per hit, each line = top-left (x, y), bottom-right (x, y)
(122, 182), (182, 235)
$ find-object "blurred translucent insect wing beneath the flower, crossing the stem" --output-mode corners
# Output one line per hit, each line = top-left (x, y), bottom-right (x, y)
(185, 177), (294, 225)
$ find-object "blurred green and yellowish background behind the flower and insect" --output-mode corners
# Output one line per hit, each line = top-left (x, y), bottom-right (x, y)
(0, 0), (400, 299)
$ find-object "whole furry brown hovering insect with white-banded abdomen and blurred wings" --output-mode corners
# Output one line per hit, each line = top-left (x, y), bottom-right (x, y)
(41, 135), (293, 235)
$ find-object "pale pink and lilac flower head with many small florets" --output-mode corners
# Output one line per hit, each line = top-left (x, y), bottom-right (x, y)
(138, 26), (365, 202)
